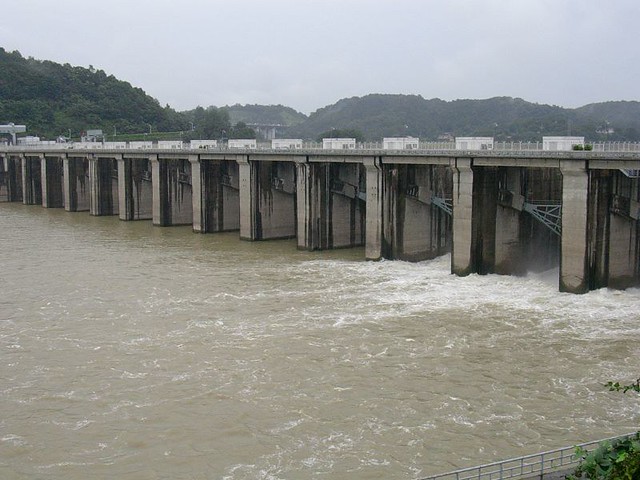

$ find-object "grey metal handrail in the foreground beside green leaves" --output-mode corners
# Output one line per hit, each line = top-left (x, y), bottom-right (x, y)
(420, 433), (636, 480)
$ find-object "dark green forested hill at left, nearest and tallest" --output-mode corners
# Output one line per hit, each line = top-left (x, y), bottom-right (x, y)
(0, 48), (189, 138)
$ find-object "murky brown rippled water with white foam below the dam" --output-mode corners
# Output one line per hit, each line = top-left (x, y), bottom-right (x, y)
(0, 204), (640, 480)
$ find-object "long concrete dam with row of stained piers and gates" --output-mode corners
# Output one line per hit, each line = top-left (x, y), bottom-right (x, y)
(0, 147), (640, 293)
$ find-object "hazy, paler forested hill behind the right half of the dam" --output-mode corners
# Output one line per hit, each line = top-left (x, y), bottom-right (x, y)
(291, 94), (640, 141)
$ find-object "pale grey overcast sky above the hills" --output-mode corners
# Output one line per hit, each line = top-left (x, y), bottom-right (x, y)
(0, 0), (640, 113)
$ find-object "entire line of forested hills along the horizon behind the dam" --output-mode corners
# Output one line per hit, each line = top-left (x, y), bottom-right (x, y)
(0, 48), (640, 141)
